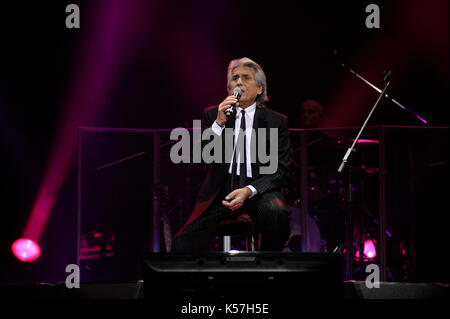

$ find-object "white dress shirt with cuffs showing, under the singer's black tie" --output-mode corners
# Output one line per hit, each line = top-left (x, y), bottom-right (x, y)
(211, 102), (257, 198)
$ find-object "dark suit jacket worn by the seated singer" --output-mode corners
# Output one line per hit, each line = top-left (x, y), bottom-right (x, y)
(177, 105), (290, 235)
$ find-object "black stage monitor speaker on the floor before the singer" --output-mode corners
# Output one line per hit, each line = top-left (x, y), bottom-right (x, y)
(142, 252), (344, 317)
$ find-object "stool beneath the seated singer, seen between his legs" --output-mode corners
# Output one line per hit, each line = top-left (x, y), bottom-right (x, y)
(216, 213), (258, 252)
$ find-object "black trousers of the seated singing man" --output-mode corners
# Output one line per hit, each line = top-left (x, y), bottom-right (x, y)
(173, 176), (290, 252)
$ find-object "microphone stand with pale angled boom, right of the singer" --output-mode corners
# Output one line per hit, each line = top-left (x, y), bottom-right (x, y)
(338, 71), (391, 280)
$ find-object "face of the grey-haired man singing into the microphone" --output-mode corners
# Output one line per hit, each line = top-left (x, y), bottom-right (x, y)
(230, 66), (262, 108)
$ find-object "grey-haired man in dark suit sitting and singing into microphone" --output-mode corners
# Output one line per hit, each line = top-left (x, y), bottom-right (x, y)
(174, 58), (289, 252)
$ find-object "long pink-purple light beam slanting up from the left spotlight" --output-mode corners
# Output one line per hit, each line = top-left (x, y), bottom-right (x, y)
(16, 0), (142, 250)
